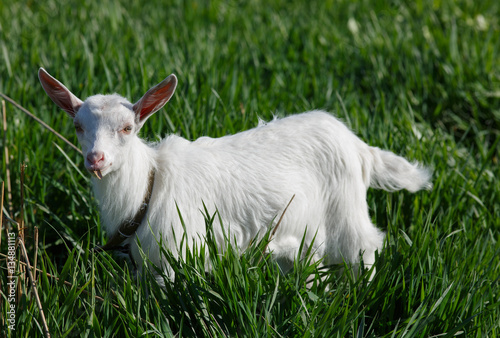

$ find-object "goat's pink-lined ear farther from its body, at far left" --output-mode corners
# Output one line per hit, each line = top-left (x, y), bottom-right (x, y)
(38, 68), (83, 118)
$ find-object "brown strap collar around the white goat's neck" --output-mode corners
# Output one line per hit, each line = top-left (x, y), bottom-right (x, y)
(93, 170), (155, 252)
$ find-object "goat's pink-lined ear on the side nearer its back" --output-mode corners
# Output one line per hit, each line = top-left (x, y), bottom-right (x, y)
(132, 74), (177, 122)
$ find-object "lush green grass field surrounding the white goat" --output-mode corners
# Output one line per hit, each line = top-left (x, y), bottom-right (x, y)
(0, 0), (500, 337)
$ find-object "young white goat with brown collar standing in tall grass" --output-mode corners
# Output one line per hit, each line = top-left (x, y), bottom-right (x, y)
(39, 68), (431, 280)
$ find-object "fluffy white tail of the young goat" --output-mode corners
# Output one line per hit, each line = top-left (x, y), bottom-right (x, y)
(363, 147), (432, 192)
